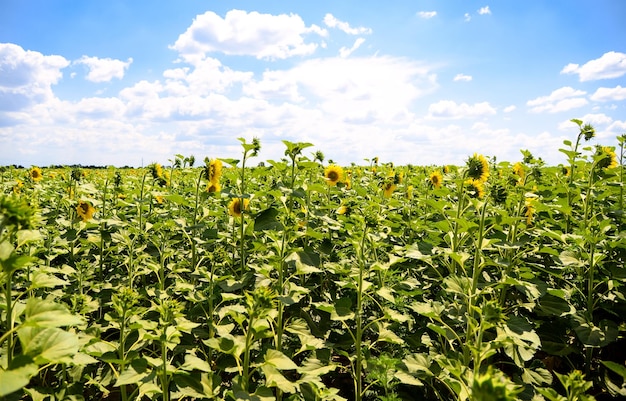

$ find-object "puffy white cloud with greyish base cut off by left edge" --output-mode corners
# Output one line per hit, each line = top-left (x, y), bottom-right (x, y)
(0, 43), (70, 112)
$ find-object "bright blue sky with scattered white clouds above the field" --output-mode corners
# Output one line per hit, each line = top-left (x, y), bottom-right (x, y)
(0, 0), (626, 166)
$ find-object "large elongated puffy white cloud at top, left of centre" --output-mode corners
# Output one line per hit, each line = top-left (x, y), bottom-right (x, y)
(170, 10), (327, 64)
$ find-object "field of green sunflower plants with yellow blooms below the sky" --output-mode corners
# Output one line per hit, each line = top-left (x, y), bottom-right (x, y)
(0, 120), (626, 401)
